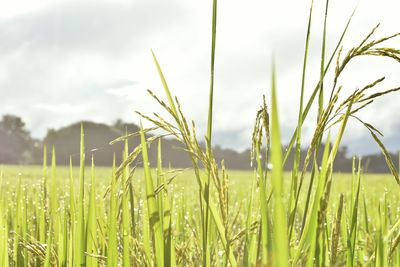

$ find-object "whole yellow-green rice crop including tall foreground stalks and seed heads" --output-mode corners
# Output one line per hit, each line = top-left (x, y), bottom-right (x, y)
(0, 0), (400, 267)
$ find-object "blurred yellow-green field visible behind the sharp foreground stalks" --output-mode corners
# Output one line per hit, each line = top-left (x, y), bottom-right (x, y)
(0, 163), (400, 266)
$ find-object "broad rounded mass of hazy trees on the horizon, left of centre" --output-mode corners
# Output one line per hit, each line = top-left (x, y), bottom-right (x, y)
(41, 120), (191, 168)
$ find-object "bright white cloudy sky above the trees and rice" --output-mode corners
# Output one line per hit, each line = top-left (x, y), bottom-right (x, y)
(0, 0), (400, 155)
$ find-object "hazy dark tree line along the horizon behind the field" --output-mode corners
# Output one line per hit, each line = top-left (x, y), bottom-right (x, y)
(0, 115), (399, 173)
